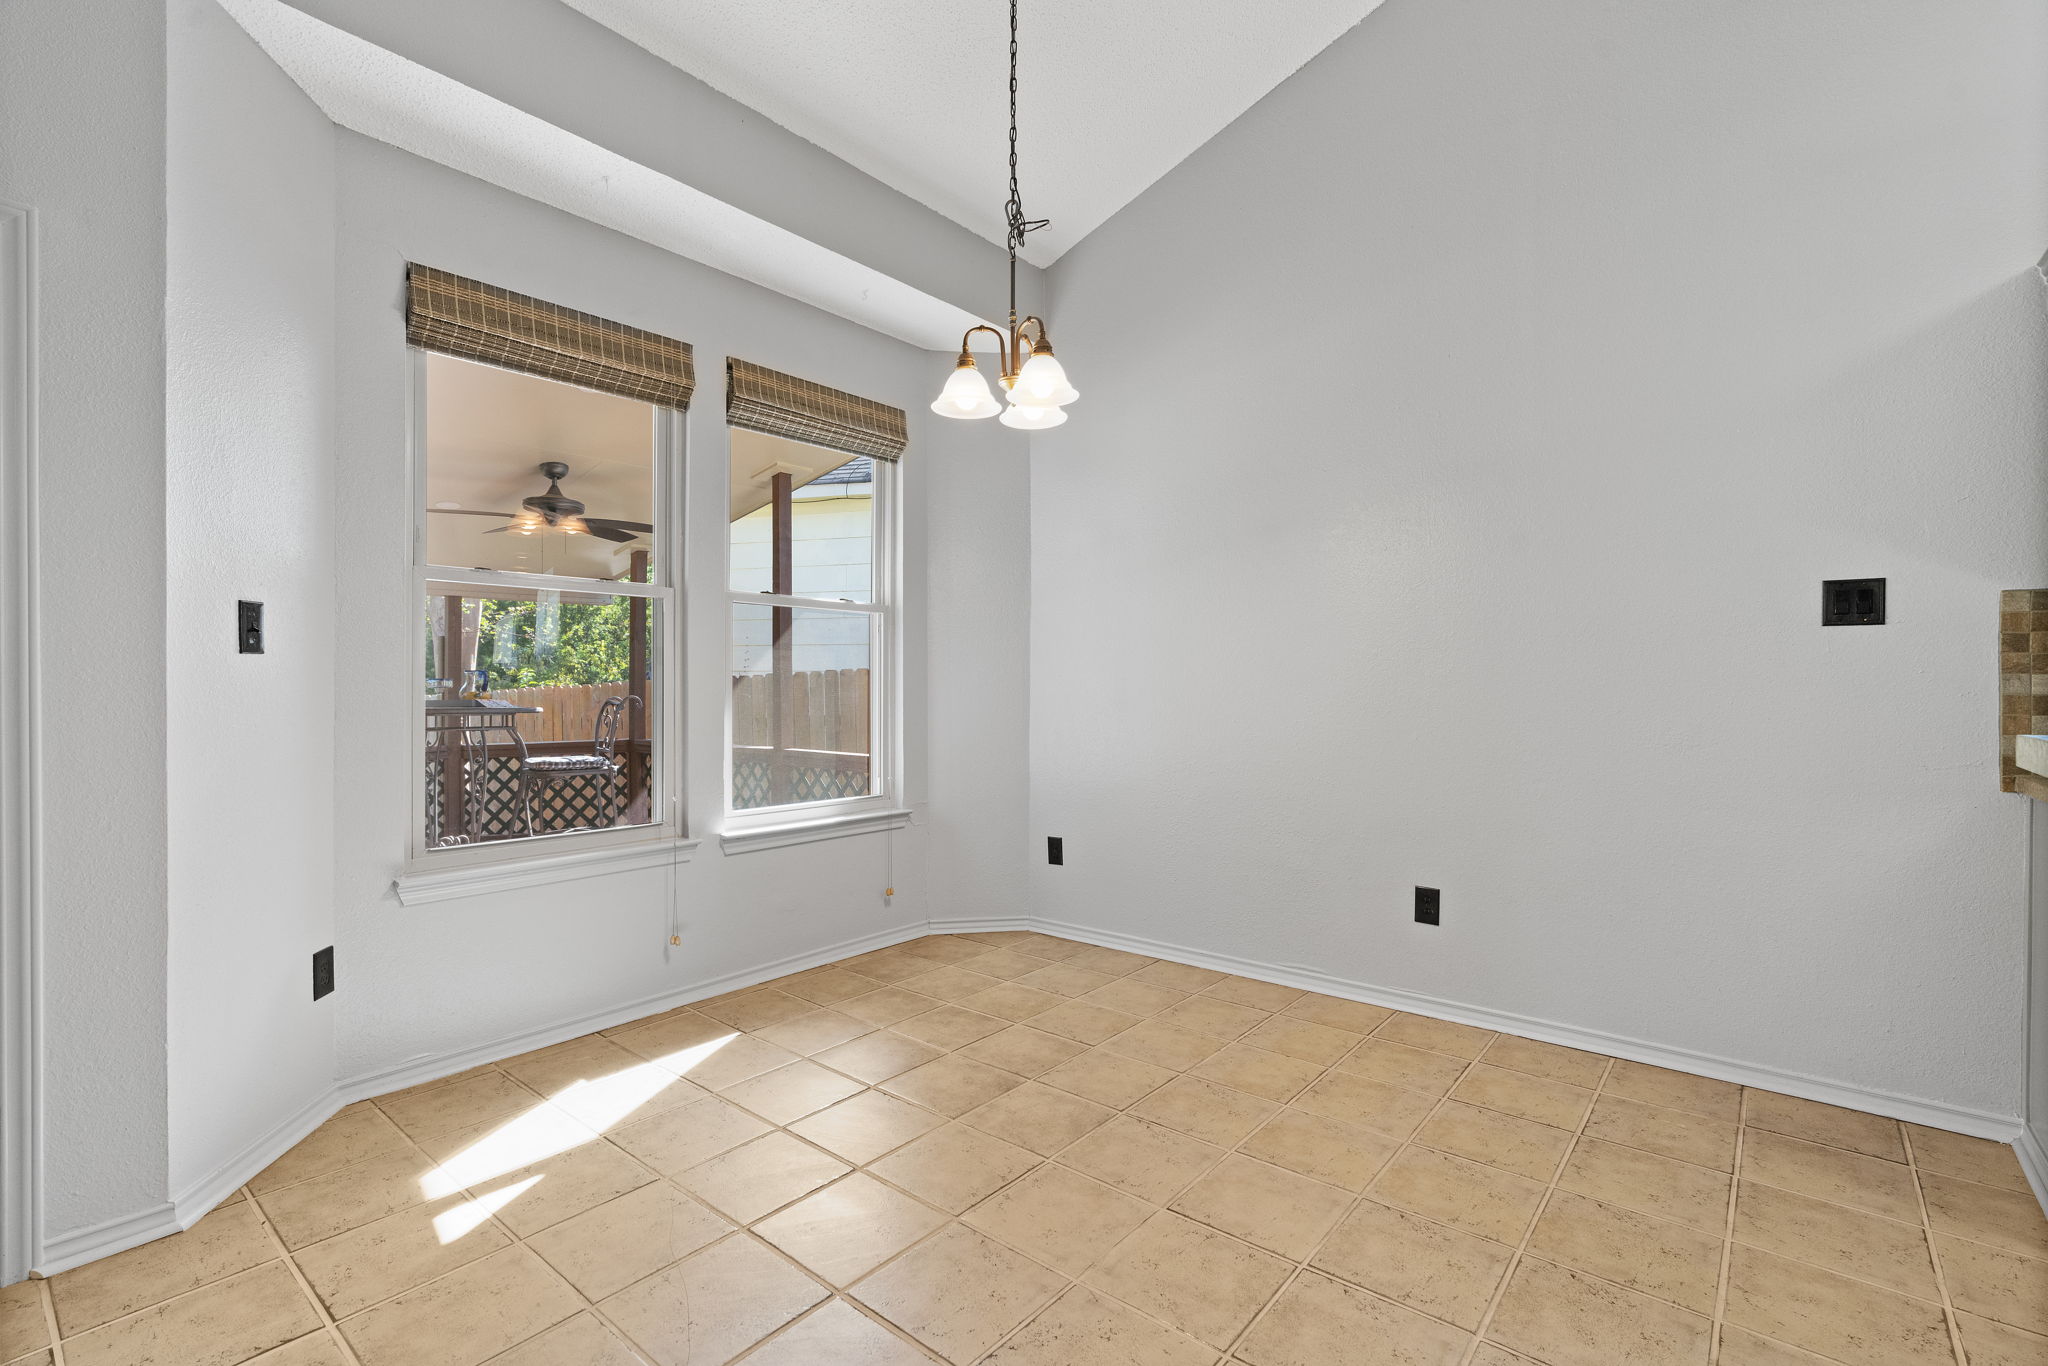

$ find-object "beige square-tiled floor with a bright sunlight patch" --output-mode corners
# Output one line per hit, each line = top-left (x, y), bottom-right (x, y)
(0, 934), (2048, 1366)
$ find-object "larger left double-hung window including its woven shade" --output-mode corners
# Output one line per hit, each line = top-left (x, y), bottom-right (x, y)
(410, 268), (688, 854)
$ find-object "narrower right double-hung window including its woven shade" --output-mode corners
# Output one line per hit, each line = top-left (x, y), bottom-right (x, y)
(727, 360), (903, 821)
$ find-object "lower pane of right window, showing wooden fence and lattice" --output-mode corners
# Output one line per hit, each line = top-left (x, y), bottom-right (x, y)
(733, 602), (877, 811)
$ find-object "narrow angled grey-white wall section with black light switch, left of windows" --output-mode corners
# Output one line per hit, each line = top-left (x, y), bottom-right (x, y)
(164, 0), (336, 1196)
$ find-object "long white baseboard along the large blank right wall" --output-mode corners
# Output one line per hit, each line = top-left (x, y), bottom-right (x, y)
(1032, 920), (2019, 1143)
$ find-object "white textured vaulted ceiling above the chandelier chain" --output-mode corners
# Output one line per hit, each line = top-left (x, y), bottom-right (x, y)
(565, 0), (1378, 264)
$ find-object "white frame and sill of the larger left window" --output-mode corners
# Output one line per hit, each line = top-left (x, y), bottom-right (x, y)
(393, 348), (696, 888)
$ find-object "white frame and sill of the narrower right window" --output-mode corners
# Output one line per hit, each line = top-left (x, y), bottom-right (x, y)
(719, 450), (909, 835)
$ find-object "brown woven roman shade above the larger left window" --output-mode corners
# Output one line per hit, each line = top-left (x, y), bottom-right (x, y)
(406, 264), (696, 418)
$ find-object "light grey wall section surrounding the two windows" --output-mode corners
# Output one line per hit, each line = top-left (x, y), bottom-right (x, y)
(334, 133), (1022, 1081)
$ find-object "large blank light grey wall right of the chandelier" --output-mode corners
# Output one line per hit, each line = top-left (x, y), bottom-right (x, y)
(1032, 0), (2048, 1116)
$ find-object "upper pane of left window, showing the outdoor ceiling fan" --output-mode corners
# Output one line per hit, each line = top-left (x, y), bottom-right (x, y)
(426, 352), (655, 580)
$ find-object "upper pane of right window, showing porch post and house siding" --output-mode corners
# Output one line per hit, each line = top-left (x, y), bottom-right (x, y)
(731, 430), (874, 602)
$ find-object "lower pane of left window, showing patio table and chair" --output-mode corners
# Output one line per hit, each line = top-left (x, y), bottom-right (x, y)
(424, 584), (662, 848)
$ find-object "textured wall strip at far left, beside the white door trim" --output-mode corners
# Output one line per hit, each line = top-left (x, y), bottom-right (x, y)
(0, 0), (166, 1237)
